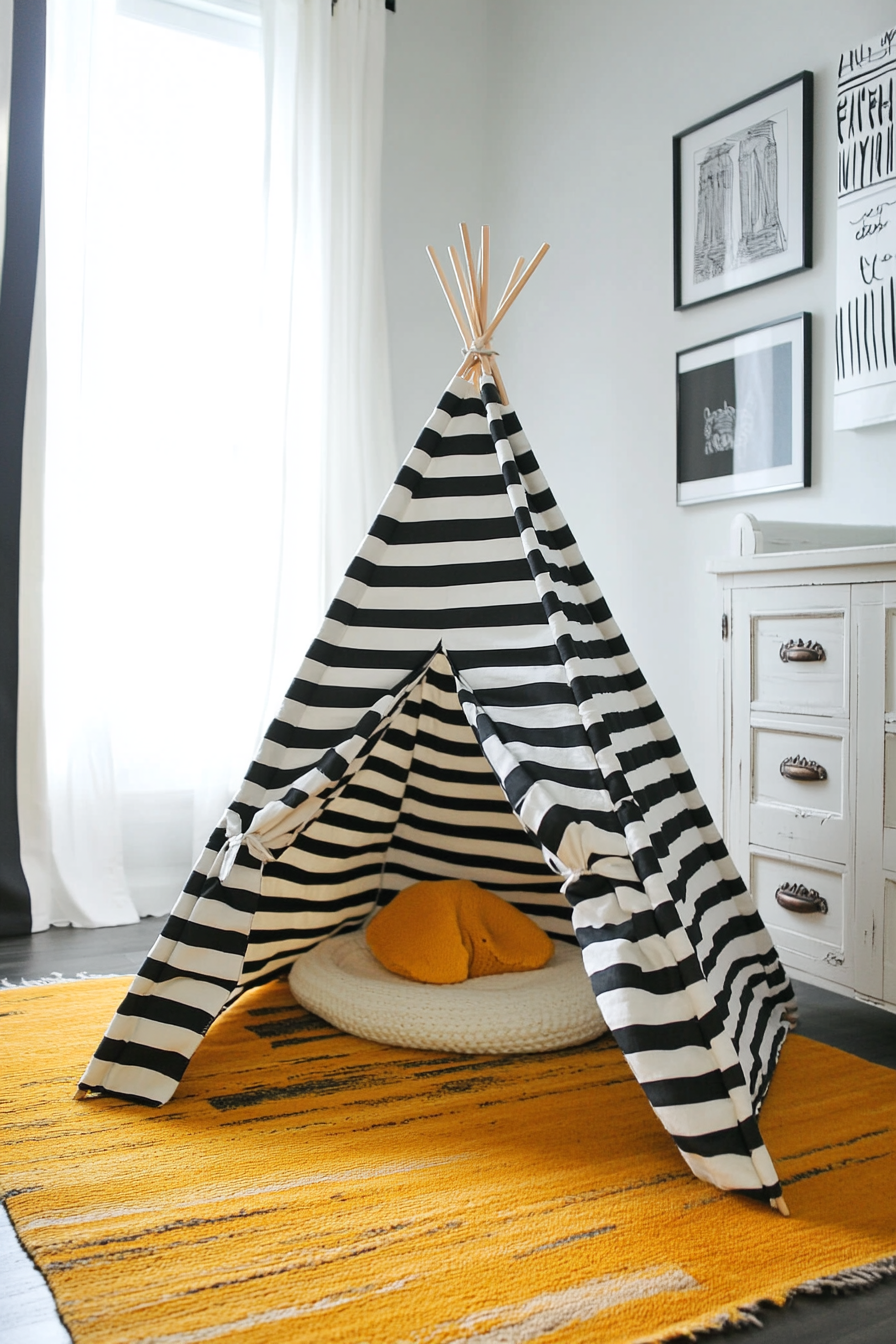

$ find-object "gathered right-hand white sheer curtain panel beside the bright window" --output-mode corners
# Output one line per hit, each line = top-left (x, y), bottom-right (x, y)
(262, 0), (396, 615)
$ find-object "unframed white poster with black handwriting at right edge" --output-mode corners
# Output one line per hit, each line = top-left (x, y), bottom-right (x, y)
(834, 28), (896, 429)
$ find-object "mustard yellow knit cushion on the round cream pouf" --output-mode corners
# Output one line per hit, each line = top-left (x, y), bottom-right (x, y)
(367, 879), (553, 985)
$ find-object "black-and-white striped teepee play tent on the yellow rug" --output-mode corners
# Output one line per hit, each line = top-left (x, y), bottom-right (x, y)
(81, 231), (794, 1211)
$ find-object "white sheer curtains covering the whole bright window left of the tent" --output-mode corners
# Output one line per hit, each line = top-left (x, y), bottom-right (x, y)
(20, 0), (394, 929)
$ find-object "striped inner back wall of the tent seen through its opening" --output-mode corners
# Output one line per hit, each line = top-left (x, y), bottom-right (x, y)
(242, 646), (576, 984)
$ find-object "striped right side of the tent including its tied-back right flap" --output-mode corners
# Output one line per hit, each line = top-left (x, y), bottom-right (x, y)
(445, 389), (793, 1198)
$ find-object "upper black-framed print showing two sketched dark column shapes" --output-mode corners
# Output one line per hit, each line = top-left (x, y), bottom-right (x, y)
(672, 70), (813, 308)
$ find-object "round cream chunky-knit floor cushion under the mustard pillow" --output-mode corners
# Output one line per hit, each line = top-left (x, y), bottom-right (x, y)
(289, 929), (607, 1055)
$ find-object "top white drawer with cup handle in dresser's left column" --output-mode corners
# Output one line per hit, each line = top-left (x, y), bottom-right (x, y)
(752, 607), (849, 718)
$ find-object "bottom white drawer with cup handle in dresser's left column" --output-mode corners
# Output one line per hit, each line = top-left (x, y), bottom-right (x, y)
(750, 852), (852, 982)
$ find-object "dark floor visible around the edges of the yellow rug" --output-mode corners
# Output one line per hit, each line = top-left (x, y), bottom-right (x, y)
(0, 919), (896, 1344)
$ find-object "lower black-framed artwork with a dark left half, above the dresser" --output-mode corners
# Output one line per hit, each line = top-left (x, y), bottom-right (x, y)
(677, 313), (811, 504)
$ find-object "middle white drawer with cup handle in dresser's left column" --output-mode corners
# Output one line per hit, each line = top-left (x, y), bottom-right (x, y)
(750, 723), (849, 863)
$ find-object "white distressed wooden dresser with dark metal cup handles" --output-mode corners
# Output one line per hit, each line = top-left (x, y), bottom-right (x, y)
(708, 513), (896, 1009)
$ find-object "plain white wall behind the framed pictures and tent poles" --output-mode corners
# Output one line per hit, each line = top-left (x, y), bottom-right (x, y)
(386, 0), (896, 814)
